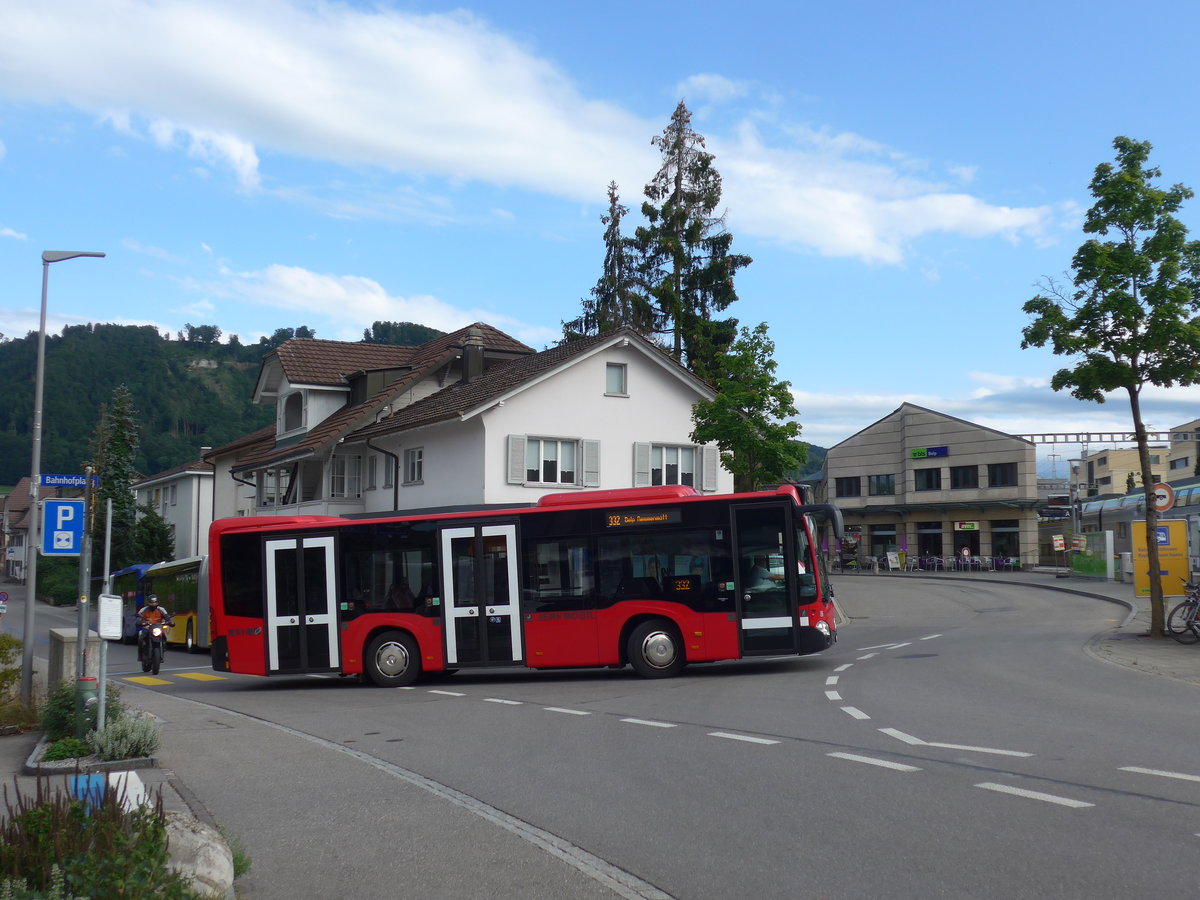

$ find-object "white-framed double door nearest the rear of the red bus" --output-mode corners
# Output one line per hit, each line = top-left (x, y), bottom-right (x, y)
(266, 536), (341, 674)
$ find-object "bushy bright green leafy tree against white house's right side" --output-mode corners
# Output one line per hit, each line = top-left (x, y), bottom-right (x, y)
(691, 323), (805, 491)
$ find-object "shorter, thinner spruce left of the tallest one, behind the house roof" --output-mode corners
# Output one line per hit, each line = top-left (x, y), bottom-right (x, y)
(563, 181), (661, 341)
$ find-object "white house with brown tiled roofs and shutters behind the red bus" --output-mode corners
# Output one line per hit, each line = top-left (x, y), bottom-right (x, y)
(205, 323), (733, 517)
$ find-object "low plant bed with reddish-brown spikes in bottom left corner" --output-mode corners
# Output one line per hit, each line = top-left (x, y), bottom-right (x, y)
(0, 779), (196, 900)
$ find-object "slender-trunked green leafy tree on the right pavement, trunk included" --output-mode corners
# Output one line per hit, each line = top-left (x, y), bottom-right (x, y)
(1021, 137), (1200, 637)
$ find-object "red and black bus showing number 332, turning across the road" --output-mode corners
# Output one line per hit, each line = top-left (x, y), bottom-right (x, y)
(209, 486), (841, 686)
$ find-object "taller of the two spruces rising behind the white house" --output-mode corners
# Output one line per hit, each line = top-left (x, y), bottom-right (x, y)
(635, 101), (751, 379)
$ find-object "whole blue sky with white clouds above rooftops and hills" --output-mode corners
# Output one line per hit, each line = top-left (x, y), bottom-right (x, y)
(0, 0), (1200, 474)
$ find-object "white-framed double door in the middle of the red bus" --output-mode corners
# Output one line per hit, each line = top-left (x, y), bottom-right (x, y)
(442, 524), (524, 668)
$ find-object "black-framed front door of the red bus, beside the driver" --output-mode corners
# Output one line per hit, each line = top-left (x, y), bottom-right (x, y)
(734, 505), (797, 656)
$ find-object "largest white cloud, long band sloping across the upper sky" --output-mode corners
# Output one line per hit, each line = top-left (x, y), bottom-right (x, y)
(0, 0), (1049, 264)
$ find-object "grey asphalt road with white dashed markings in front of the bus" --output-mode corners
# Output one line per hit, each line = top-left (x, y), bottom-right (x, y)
(9, 577), (1200, 900)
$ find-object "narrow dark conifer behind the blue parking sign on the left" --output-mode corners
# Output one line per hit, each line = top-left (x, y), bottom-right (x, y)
(91, 384), (141, 575)
